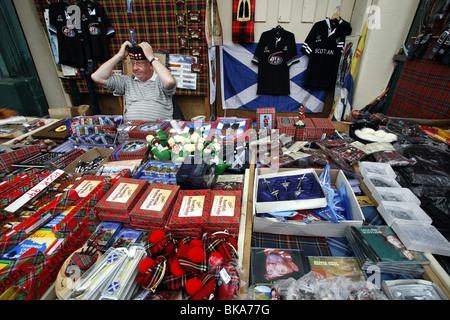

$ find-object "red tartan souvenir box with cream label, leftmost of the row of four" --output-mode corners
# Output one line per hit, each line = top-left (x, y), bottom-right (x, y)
(94, 178), (147, 224)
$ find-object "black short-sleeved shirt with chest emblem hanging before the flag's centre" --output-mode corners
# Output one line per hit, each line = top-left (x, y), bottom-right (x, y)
(252, 27), (300, 95)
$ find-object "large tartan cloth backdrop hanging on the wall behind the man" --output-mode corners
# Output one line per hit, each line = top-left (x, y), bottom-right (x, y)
(34, 0), (208, 96)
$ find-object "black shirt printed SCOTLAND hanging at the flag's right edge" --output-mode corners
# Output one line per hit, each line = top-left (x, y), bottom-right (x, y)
(302, 18), (352, 90)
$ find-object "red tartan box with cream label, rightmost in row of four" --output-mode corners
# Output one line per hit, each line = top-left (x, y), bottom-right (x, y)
(205, 190), (242, 236)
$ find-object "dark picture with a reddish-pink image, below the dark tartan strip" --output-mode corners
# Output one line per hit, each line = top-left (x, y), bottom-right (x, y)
(250, 248), (309, 285)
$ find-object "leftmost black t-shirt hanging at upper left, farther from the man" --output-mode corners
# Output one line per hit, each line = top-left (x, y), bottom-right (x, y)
(48, 2), (84, 68)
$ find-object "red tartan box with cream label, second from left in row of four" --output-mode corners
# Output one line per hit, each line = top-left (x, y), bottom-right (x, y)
(130, 183), (180, 230)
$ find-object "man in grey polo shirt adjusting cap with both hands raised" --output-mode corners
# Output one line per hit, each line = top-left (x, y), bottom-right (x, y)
(91, 41), (176, 121)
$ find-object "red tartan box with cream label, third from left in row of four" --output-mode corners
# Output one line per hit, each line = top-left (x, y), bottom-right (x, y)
(166, 190), (212, 232)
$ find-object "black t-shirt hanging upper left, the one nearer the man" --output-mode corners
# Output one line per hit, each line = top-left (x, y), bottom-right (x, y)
(80, 1), (115, 61)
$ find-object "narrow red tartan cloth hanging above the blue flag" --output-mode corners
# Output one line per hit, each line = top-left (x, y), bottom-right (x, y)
(231, 0), (255, 42)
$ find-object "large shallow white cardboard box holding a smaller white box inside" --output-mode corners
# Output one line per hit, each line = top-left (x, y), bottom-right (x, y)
(253, 169), (364, 237)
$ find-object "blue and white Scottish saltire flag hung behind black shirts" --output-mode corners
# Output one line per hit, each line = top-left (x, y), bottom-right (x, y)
(220, 41), (326, 113)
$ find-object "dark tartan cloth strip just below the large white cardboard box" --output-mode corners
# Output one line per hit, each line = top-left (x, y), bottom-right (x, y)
(251, 232), (331, 256)
